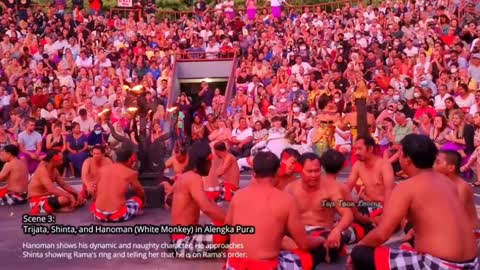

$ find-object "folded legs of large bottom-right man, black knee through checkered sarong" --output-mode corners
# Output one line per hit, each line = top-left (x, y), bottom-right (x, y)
(351, 245), (479, 270)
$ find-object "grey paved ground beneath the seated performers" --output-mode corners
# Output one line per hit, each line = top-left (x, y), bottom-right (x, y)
(0, 168), (480, 270)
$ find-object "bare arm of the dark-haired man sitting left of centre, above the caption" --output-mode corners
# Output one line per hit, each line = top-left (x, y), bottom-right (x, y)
(188, 177), (225, 222)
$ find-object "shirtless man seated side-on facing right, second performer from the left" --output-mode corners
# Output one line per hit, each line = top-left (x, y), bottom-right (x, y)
(28, 150), (85, 215)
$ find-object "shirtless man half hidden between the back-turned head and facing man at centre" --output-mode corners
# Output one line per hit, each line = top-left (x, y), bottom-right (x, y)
(274, 148), (302, 190)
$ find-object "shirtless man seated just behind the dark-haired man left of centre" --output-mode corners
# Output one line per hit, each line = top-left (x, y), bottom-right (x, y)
(205, 142), (240, 203)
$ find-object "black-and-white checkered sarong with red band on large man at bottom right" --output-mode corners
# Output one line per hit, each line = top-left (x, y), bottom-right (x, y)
(375, 247), (479, 270)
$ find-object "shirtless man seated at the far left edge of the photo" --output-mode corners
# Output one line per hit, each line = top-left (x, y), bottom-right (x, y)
(0, 144), (28, 206)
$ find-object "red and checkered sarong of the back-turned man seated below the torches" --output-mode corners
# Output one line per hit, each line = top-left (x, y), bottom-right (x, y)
(90, 196), (143, 222)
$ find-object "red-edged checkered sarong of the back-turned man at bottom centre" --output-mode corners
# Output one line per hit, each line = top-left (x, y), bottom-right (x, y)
(225, 250), (311, 270)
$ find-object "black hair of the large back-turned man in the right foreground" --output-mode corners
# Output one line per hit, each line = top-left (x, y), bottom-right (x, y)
(400, 134), (438, 169)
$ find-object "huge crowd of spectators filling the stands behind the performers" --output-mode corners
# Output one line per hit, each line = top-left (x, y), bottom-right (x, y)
(0, 0), (480, 184)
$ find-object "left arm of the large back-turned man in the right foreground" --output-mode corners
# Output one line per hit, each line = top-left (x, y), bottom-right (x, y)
(358, 184), (410, 247)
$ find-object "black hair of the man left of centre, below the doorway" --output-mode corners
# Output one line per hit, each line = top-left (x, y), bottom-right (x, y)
(185, 142), (212, 176)
